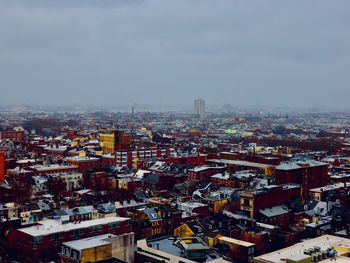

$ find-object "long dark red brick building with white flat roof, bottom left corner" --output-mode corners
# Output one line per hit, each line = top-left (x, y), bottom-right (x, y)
(9, 217), (131, 262)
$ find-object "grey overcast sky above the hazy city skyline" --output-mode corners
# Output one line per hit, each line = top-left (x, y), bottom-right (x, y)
(0, 0), (350, 108)
